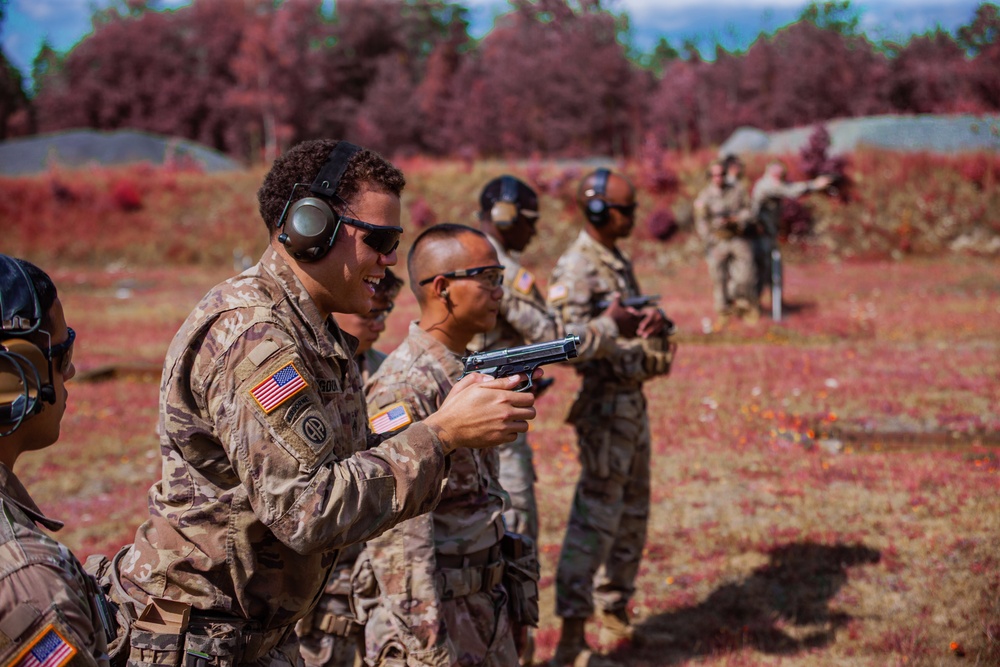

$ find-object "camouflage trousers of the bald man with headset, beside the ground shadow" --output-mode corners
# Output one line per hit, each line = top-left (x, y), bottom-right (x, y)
(556, 388), (650, 618)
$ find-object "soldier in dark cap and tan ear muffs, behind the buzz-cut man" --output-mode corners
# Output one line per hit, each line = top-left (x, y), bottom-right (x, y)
(471, 175), (639, 664)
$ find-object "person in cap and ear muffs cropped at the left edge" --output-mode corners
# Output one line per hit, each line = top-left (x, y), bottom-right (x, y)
(0, 255), (108, 667)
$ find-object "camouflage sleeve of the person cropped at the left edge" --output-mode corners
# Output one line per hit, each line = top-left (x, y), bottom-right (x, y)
(0, 528), (108, 667)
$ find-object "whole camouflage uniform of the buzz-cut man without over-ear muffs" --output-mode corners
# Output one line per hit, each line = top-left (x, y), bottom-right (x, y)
(362, 323), (518, 667)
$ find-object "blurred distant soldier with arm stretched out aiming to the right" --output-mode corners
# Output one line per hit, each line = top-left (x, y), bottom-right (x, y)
(751, 160), (833, 302)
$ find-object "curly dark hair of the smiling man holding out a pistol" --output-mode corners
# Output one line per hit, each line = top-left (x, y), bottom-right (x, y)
(257, 139), (406, 235)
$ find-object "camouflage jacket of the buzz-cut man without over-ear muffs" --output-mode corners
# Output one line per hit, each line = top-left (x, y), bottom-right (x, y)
(365, 323), (510, 664)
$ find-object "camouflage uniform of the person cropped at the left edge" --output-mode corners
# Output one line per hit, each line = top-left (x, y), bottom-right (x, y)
(0, 463), (108, 667)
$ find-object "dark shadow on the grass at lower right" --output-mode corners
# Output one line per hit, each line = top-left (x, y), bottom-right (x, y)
(608, 542), (880, 665)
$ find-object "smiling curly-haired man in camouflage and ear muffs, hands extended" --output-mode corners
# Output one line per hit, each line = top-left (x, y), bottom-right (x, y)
(116, 140), (534, 667)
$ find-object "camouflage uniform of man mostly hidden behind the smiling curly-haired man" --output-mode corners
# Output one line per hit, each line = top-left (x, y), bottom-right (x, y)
(295, 348), (387, 667)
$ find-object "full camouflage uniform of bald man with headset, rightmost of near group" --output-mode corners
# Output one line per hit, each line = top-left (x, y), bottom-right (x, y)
(549, 231), (650, 617)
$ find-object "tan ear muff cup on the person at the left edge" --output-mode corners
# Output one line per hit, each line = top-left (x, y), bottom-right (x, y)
(0, 338), (47, 425)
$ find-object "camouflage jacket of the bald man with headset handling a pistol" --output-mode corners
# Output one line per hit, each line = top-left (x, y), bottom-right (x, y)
(548, 230), (648, 399)
